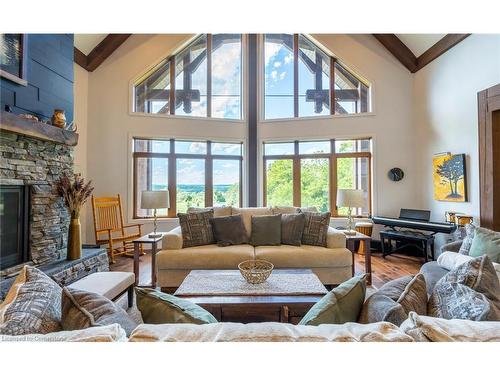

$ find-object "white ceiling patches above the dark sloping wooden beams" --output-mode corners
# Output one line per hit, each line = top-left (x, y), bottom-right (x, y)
(75, 34), (446, 57)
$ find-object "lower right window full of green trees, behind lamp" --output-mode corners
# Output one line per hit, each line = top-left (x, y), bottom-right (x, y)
(263, 139), (371, 216)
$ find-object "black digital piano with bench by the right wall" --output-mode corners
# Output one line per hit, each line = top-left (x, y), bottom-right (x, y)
(372, 208), (456, 262)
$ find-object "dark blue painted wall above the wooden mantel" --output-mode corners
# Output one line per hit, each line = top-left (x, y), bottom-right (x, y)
(0, 34), (74, 124)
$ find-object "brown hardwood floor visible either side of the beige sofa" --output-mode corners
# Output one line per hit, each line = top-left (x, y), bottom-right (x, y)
(110, 250), (423, 288)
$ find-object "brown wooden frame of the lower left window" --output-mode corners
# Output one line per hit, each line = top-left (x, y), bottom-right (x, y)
(132, 137), (243, 219)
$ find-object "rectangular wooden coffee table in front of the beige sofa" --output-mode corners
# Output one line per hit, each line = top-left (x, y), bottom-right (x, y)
(175, 269), (328, 324)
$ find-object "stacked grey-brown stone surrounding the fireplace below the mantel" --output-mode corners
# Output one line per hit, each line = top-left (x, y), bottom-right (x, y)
(0, 131), (73, 264)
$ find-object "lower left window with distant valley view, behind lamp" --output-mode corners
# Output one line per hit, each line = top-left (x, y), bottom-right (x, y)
(133, 138), (243, 218)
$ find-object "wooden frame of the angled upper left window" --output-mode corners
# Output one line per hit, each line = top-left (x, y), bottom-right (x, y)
(133, 34), (244, 121)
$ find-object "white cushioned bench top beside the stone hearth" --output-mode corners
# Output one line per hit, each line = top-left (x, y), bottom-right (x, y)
(69, 271), (135, 299)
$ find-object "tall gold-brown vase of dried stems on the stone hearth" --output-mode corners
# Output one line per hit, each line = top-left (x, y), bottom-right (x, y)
(55, 174), (94, 260)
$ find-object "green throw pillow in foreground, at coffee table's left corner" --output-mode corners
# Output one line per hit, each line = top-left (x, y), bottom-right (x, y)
(135, 288), (217, 324)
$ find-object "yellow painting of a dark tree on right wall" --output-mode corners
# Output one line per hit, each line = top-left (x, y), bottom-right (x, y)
(432, 153), (467, 202)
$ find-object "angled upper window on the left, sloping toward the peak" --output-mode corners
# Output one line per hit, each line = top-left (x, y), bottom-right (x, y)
(134, 34), (242, 119)
